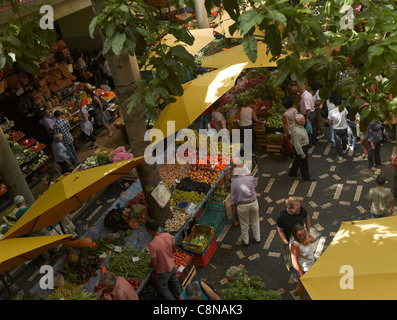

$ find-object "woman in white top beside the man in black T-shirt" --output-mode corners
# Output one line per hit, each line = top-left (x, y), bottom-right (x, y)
(289, 224), (314, 300)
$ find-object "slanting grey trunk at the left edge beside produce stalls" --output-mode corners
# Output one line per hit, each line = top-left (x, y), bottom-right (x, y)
(0, 129), (35, 205)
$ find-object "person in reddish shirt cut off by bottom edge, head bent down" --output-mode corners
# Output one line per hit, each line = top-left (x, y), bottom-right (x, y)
(96, 271), (139, 300)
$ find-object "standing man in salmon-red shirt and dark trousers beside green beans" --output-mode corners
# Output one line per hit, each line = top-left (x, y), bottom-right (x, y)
(146, 219), (181, 300)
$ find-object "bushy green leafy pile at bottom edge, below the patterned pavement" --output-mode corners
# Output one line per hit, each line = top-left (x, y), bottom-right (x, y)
(220, 269), (281, 300)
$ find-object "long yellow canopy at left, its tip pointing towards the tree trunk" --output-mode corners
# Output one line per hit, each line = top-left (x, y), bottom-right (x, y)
(0, 157), (144, 242)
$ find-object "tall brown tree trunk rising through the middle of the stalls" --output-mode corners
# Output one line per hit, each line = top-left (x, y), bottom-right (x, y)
(91, 0), (172, 226)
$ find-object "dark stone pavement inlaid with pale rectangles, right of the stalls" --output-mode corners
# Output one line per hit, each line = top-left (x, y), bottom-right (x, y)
(195, 132), (394, 300)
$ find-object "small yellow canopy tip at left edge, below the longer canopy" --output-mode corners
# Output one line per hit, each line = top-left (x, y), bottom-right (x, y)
(0, 234), (72, 274)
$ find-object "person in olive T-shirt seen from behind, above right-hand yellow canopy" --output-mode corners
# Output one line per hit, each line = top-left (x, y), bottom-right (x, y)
(366, 175), (395, 219)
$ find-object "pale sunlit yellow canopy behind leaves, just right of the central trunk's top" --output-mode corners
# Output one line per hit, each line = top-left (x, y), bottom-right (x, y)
(141, 28), (215, 70)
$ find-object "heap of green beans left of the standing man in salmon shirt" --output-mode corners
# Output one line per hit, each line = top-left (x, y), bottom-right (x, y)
(108, 248), (150, 280)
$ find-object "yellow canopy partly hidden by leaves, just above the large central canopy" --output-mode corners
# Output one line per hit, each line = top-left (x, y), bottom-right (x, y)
(201, 42), (285, 68)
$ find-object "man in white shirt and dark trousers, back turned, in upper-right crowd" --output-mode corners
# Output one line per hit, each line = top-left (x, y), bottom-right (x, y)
(328, 97), (349, 160)
